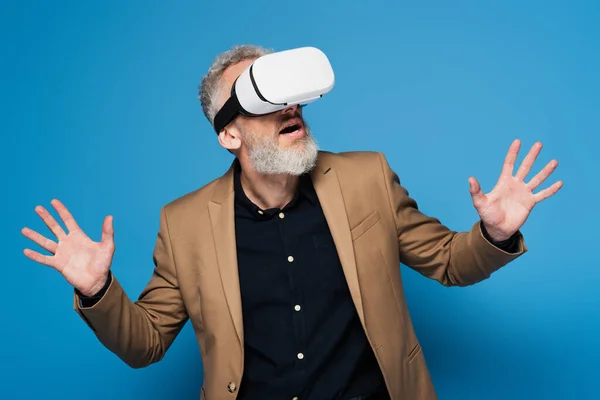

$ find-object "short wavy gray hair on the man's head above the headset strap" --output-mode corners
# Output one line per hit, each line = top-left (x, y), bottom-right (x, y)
(198, 44), (273, 125)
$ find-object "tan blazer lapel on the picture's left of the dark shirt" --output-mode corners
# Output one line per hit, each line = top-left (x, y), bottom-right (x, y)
(208, 165), (244, 350)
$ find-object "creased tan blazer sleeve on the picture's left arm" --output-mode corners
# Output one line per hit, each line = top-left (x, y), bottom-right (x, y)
(74, 207), (188, 368)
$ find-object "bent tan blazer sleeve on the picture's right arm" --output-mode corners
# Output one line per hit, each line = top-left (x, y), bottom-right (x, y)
(379, 153), (527, 286)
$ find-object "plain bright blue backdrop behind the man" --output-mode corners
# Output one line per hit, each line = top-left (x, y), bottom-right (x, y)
(0, 0), (600, 400)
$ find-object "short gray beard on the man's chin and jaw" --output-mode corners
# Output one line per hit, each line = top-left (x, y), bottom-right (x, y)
(244, 124), (319, 176)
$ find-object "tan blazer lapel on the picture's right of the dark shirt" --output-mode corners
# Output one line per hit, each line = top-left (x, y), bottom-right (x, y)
(311, 153), (364, 325)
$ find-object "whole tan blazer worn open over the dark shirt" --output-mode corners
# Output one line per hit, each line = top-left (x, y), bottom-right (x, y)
(74, 152), (526, 400)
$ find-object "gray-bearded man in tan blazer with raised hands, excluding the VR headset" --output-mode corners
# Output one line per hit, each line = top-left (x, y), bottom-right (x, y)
(23, 46), (562, 400)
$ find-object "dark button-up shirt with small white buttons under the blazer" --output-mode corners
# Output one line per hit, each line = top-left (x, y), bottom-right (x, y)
(234, 163), (385, 400)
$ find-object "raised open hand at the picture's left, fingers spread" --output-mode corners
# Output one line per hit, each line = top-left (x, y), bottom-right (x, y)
(22, 200), (115, 296)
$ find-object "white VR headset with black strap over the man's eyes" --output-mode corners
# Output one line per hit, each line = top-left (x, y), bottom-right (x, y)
(214, 47), (335, 134)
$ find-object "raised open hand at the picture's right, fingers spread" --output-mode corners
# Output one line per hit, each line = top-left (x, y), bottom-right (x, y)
(469, 140), (562, 241)
